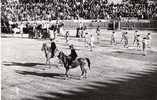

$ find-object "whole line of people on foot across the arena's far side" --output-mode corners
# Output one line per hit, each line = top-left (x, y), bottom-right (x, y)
(9, 21), (151, 55)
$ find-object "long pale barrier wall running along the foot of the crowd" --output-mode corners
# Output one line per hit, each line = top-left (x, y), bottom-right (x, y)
(1, 19), (157, 34)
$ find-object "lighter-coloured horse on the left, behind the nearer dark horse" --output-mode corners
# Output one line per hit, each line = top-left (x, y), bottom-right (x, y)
(41, 43), (57, 68)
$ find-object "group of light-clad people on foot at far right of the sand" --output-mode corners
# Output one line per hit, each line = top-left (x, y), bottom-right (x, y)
(110, 30), (152, 56)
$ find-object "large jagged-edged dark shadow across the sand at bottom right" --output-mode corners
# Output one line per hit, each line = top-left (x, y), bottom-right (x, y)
(22, 68), (157, 100)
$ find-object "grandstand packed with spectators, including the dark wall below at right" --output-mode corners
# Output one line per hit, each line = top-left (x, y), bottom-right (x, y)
(1, 0), (157, 33)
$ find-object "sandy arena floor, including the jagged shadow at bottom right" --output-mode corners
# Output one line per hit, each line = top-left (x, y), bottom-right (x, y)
(1, 29), (157, 100)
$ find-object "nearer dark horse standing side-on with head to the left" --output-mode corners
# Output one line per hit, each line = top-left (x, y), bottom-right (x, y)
(57, 51), (90, 78)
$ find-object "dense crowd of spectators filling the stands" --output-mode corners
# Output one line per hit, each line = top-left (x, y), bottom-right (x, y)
(2, 0), (157, 21)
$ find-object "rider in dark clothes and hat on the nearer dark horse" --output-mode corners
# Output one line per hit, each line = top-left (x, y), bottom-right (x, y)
(68, 45), (77, 65)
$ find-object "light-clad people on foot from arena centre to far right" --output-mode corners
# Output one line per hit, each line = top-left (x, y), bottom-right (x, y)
(65, 26), (152, 56)
